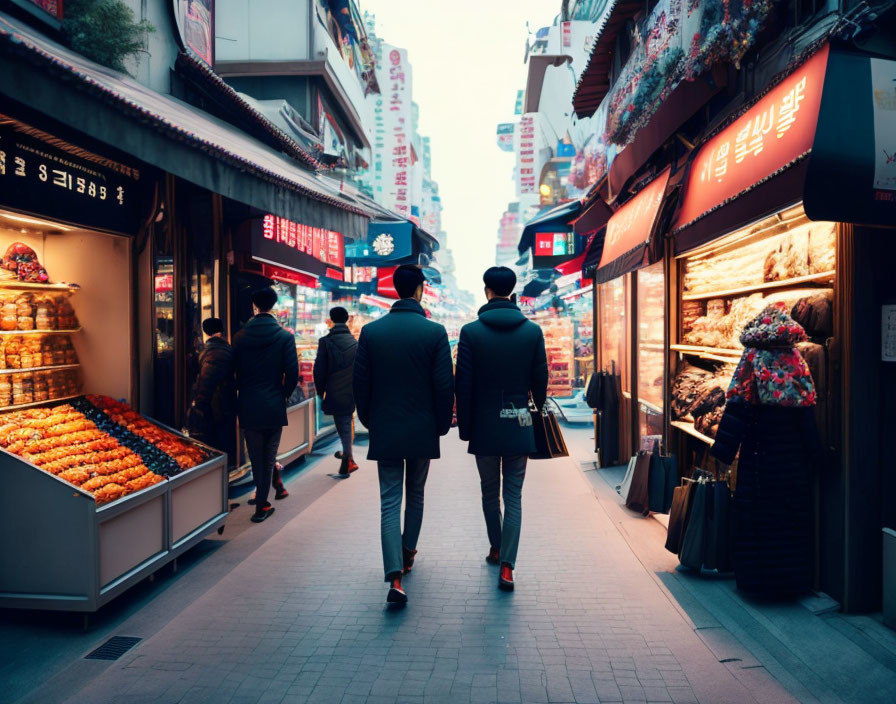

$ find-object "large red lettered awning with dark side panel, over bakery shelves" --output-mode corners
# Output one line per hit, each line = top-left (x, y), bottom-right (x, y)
(672, 45), (896, 254)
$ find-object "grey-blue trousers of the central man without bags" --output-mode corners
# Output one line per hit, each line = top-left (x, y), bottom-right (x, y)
(377, 459), (429, 582)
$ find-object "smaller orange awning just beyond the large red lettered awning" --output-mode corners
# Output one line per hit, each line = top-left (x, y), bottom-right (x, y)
(594, 168), (671, 283)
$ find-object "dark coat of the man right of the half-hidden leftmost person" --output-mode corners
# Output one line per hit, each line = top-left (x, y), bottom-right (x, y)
(233, 313), (299, 430)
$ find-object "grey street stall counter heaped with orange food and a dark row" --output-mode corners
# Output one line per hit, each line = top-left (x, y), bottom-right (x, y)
(0, 396), (228, 612)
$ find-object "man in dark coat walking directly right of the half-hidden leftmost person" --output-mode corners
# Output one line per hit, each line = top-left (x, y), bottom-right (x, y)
(233, 287), (299, 523)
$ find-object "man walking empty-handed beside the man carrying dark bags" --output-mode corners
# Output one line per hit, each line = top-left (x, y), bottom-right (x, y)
(354, 265), (454, 604)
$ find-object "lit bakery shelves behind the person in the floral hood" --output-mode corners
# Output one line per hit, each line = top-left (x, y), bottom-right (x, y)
(670, 206), (837, 444)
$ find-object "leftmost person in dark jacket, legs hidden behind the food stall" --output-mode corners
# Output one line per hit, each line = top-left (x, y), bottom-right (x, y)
(187, 318), (236, 463)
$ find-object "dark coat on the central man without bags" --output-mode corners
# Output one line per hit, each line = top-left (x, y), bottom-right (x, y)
(353, 298), (454, 460)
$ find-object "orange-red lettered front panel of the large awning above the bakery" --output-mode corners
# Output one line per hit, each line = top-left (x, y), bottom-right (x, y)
(676, 45), (830, 229)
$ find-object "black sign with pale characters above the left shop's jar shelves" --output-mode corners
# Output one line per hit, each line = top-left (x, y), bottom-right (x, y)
(0, 119), (148, 235)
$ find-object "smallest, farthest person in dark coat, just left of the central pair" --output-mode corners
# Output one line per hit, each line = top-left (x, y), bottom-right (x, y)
(314, 306), (358, 477)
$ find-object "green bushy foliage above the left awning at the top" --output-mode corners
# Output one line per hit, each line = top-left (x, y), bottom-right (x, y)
(62, 0), (156, 71)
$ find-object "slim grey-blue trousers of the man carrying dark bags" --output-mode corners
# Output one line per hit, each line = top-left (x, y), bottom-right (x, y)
(476, 455), (529, 569)
